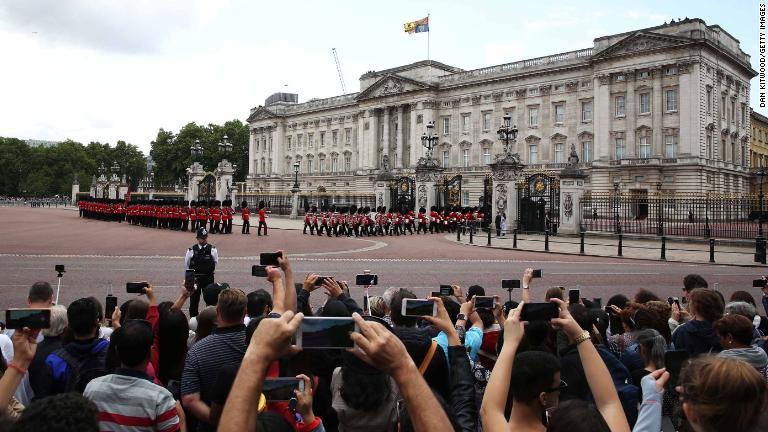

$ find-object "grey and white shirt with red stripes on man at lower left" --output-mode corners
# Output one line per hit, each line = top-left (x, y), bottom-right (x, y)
(83, 369), (179, 432)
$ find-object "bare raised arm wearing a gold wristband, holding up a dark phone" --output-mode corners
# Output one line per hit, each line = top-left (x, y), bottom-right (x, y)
(550, 298), (629, 432)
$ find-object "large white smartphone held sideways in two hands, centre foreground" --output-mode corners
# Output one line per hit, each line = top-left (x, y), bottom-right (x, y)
(296, 317), (357, 349)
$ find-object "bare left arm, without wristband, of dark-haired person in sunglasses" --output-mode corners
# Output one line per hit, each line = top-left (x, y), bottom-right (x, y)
(480, 302), (525, 432)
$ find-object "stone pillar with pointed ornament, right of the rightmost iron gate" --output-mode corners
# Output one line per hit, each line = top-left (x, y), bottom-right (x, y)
(559, 144), (587, 234)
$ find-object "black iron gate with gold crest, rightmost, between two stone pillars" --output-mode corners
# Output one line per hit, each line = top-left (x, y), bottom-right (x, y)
(517, 173), (560, 234)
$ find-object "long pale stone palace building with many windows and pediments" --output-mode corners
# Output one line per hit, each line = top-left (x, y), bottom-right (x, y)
(247, 19), (757, 205)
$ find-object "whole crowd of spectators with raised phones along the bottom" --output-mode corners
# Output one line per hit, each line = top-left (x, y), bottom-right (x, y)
(0, 258), (768, 432)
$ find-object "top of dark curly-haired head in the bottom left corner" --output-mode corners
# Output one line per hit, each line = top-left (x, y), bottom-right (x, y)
(12, 392), (99, 432)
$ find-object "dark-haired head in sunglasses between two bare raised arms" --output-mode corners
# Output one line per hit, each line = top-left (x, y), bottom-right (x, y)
(510, 351), (562, 413)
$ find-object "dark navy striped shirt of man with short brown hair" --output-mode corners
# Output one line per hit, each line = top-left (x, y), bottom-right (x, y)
(181, 324), (246, 432)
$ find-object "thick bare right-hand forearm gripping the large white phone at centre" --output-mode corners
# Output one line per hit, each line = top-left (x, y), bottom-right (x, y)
(352, 313), (453, 432)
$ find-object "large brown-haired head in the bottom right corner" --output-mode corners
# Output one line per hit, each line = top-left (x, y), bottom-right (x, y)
(678, 356), (768, 432)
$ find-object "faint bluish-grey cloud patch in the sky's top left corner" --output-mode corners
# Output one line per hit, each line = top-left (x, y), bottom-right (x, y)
(0, 0), (221, 54)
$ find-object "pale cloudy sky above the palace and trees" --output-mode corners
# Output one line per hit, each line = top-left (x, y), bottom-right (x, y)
(0, 0), (768, 154)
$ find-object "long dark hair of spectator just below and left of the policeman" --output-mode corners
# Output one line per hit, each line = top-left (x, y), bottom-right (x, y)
(157, 309), (189, 383)
